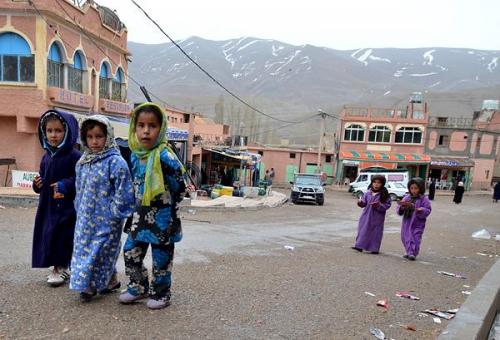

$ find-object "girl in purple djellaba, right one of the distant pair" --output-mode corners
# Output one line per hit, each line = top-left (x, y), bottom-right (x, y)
(397, 177), (432, 261)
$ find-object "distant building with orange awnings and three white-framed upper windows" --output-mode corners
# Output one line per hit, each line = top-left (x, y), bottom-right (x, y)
(337, 93), (430, 181)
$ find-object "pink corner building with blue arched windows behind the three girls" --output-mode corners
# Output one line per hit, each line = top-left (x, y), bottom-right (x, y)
(0, 0), (131, 183)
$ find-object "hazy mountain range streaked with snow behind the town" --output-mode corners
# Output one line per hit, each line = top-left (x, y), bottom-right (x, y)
(128, 37), (500, 127)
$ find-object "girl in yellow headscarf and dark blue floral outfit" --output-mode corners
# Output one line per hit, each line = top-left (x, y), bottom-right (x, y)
(120, 103), (186, 309)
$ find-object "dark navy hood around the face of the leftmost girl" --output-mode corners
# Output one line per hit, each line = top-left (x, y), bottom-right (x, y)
(38, 109), (78, 154)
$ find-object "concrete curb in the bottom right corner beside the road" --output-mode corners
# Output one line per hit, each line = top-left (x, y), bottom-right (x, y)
(438, 260), (500, 340)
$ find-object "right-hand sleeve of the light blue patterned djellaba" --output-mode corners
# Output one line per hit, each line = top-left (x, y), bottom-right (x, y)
(110, 157), (135, 220)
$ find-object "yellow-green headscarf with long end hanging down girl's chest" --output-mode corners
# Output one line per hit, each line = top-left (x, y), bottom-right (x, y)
(128, 102), (167, 206)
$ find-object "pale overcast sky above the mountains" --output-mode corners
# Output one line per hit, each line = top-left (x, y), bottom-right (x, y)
(97, 0), (500, 50)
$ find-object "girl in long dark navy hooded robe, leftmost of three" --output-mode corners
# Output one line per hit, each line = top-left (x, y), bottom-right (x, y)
(32, 110), (81, 287)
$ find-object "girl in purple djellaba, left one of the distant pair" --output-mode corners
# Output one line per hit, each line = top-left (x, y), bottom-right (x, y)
(352, 175), (391, 254)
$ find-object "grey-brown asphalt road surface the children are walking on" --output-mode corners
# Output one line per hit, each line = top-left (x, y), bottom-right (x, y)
(0, 192), (500, 339)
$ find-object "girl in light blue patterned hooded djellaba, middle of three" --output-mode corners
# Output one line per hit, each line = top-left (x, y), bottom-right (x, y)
(70, 115), (134, 302)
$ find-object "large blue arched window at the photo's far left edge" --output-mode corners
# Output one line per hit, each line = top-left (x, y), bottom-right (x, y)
(0, 32), (35, 83)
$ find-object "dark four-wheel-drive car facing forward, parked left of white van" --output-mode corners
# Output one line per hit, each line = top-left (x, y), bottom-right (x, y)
(290, 174), (326, 205)
